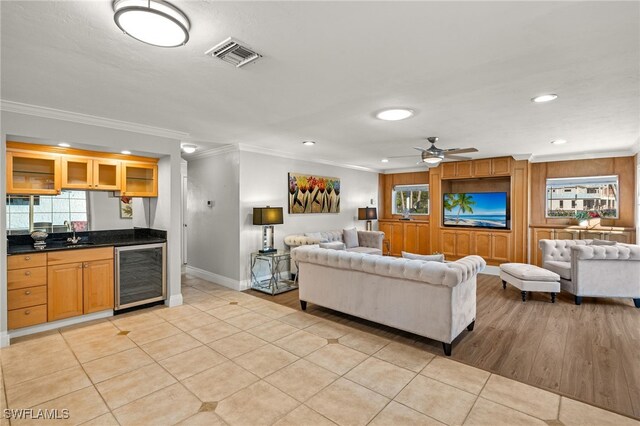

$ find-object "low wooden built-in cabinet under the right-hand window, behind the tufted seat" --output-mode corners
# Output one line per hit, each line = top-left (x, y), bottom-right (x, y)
(529, 226), (636, 266)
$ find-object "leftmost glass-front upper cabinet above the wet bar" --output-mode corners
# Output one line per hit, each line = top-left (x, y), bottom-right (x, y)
(7, 151), (62, 194)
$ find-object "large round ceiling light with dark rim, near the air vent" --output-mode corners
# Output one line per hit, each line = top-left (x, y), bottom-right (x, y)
(113, 0), (191, 47)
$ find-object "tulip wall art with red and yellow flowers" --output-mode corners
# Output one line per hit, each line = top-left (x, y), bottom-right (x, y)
(289, 173), (340, 214)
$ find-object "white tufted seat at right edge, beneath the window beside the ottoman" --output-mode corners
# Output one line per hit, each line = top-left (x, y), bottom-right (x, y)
(539, 240), (640, 308)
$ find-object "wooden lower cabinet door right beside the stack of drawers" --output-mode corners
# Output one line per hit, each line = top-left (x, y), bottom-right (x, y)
(48, 262), (83, 321)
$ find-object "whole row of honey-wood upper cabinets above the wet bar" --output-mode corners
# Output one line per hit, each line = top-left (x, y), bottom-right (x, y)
(7, 142), (158, 197)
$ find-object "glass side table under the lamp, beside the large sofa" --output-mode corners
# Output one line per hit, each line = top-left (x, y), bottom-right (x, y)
(251, 251), (298, 296)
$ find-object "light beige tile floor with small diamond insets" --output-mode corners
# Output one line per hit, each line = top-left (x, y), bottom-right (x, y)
(0, 276), (640, 426)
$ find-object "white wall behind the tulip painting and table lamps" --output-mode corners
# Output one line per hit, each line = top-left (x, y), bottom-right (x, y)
(240, 151), (378, 287)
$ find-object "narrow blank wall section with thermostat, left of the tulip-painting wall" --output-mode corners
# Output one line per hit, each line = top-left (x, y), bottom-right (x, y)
(187, 150), (240, 288)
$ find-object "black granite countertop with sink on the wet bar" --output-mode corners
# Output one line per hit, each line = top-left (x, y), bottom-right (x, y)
(7, 228), (167, 256)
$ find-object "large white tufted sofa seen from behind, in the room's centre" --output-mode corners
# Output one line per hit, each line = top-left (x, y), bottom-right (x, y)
(291, 246), (486, 355)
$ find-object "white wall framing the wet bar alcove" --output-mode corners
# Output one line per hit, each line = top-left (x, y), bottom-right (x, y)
(0, 111), (182, 344)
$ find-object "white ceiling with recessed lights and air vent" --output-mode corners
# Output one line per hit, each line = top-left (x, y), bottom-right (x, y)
(0, 0), (640, 169)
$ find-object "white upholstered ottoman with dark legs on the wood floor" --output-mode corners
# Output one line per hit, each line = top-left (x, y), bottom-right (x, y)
(500, 263), (560, 303)
